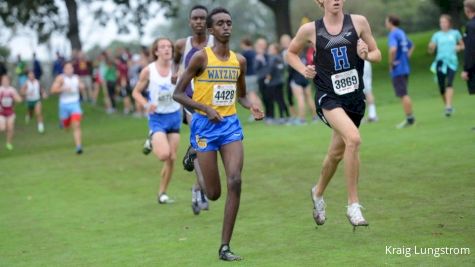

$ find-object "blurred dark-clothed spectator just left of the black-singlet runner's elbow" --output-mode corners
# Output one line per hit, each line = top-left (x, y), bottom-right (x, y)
(265, 43), (289, 124)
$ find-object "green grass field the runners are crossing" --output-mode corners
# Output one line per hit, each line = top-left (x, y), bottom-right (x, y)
(0, 31), (475, 266)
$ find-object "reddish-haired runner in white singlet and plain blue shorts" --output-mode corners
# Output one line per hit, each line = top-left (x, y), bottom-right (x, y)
(132, 38), (182, 204)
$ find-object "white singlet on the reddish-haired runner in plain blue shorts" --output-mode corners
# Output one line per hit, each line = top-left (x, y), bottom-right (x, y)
(148, 62), (181, 114)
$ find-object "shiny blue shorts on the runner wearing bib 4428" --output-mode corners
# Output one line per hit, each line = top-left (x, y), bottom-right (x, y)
(190, 113), (244, 152)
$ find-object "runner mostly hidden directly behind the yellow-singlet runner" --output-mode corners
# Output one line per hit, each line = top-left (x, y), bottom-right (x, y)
(174, 5), (214, 215)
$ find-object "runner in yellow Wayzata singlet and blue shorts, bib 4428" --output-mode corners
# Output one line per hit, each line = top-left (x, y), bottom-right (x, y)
(173, 8), (264, 261)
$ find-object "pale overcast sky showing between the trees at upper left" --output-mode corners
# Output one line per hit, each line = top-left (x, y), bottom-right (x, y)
(0, 0), (165, 60)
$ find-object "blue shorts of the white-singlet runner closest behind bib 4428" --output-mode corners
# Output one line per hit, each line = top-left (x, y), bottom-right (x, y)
(148, 110), (181, 134)
